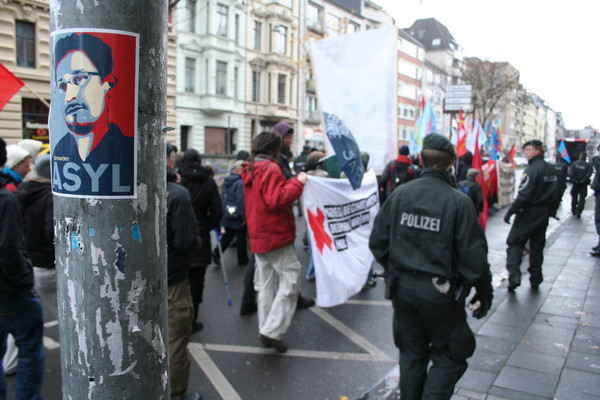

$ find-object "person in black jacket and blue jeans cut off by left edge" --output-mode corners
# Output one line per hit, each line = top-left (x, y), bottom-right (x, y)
(0, 138), (45, 399)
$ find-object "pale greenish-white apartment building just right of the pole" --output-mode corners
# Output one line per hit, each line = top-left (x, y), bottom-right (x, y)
(172, 0), (249, 154)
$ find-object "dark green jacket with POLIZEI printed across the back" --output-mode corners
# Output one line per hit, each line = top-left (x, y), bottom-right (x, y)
(369, 168), (491, 290)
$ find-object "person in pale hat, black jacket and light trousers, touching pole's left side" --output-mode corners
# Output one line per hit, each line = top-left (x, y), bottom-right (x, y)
(15, 154), (58, 320)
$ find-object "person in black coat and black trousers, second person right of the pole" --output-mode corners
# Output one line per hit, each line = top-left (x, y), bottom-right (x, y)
(179, 149), (223, 332)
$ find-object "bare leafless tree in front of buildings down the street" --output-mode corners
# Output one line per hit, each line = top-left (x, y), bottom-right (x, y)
(461, 57), (523, 126)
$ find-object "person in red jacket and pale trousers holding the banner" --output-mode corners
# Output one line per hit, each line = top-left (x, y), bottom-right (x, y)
(242, 131), (307, 353)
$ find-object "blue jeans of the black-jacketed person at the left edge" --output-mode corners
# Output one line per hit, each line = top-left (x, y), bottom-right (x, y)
(0, 292), (45, 400)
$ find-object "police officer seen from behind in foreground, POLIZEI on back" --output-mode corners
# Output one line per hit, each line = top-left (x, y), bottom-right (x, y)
(369, 133), (493, 400)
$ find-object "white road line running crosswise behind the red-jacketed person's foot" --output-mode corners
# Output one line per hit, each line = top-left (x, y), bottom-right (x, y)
(198, 343), (396, 363)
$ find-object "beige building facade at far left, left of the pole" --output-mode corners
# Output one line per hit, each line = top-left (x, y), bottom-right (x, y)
(0, 0), (50, 143)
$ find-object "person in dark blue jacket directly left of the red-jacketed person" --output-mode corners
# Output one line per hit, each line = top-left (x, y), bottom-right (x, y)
(213, 160), (248, 265)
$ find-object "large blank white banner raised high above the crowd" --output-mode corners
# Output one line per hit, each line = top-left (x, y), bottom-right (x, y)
(310, 27), (398, 174)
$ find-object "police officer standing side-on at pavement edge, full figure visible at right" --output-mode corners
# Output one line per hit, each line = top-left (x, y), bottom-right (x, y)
(504, 139), (560, 292)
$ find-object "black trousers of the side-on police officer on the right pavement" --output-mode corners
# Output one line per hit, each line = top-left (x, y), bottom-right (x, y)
(506, 207), (550, 285)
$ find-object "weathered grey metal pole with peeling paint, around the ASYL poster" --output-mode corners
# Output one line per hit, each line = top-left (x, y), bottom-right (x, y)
(50, 0), (169, 399)
